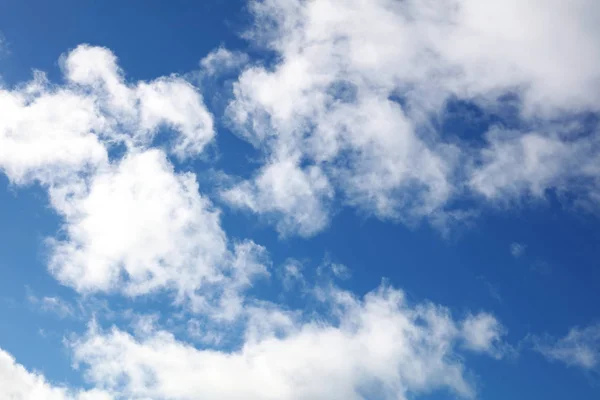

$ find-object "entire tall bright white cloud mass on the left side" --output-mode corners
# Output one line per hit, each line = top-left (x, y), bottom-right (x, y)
(0, 45), (268, 319)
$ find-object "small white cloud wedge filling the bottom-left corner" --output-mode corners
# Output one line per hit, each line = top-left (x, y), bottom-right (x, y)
(0, 349), (113, 400)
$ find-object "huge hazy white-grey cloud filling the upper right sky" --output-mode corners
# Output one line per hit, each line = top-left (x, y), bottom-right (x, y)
(225, 0), (600, 236)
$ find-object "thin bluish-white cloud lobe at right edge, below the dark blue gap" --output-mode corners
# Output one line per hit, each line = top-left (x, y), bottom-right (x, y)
(469, 125), (600, 207)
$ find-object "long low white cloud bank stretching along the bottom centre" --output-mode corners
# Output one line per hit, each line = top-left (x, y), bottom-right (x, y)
(71, 288), (502, 400)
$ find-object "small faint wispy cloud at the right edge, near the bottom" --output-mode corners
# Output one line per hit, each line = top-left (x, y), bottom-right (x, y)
(533, 324), (600, 370)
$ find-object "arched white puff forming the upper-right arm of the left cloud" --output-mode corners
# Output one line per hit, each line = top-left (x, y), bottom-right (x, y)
(62, 45), (214, 158)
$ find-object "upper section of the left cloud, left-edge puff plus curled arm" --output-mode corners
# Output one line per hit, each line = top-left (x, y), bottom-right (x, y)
(0, 45), (214, 184)
